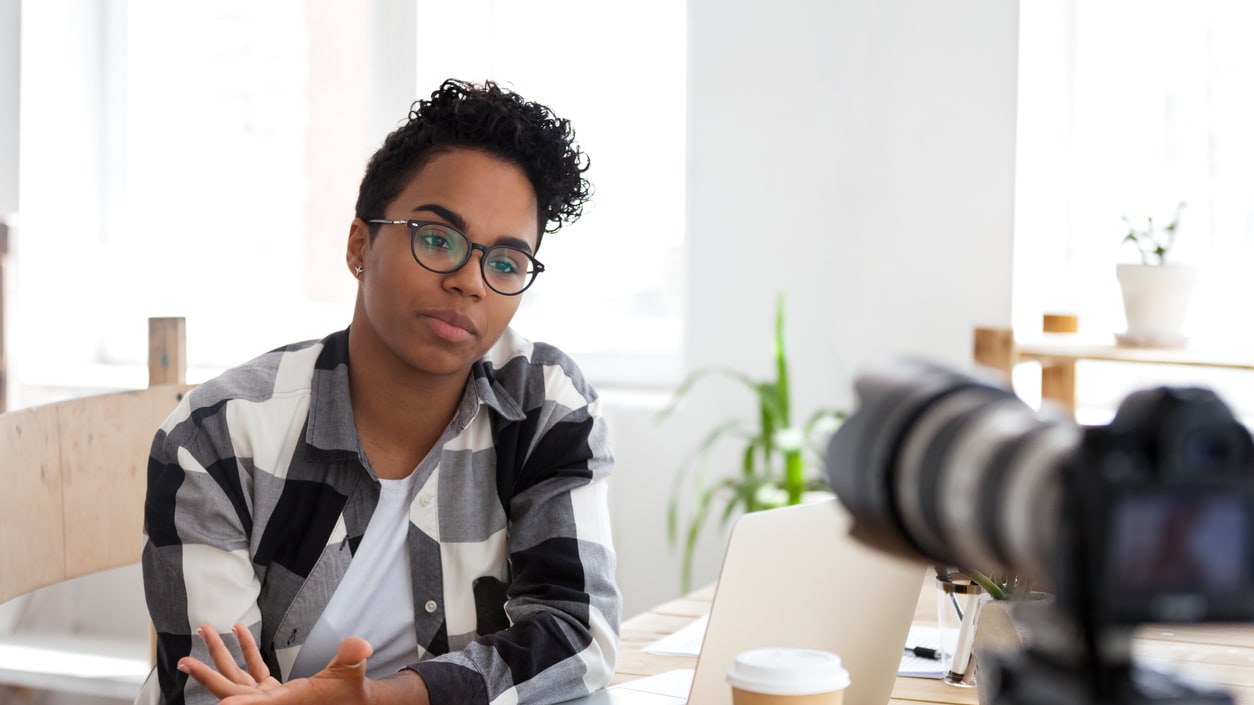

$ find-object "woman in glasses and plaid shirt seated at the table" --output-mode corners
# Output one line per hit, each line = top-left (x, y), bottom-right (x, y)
(140, 80), (621, 705)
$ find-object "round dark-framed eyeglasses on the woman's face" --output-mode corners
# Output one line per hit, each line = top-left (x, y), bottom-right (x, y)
(366, 220), (544, 296)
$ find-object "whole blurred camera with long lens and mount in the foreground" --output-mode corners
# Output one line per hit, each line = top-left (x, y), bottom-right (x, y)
(826, 360), (1254, 705)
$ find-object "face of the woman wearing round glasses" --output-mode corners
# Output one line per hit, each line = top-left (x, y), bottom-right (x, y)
(347, 149), (539, 376)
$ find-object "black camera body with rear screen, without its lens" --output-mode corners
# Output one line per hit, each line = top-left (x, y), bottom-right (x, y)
(1053, 388), (1254, 625)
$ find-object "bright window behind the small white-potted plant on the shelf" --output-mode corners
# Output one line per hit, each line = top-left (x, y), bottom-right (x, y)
(1014, 0), (1254, 420)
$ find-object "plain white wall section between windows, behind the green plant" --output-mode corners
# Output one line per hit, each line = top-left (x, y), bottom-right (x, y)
(609, 0), (1018, 615)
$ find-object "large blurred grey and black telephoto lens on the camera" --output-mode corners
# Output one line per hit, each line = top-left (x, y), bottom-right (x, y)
(828, 360), (1081, 580)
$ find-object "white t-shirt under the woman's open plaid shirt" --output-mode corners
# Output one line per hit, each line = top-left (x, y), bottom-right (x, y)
(291, 473), (418, 679)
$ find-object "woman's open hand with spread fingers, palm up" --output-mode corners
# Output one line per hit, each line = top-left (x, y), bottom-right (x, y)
(178, 625), (374, 705)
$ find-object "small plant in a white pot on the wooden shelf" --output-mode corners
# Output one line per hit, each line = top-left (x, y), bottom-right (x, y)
(1115, 201), (1198, 347)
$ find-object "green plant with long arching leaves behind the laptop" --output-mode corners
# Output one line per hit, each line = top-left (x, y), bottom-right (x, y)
(657, 295), (845, 592)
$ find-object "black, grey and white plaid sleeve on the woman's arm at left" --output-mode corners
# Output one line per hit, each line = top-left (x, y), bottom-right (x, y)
(142, 395), (261, 704)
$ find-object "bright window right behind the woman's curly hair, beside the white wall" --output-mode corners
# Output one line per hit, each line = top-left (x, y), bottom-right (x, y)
(415, 0), (686, 384)
